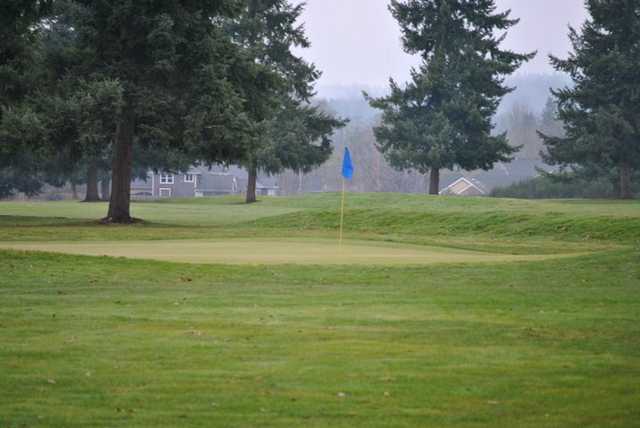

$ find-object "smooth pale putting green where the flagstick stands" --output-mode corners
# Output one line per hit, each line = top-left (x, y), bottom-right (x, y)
(0, 239), (580, 265)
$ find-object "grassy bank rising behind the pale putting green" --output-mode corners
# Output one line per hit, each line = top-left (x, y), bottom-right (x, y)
(0, 194), (640, 244)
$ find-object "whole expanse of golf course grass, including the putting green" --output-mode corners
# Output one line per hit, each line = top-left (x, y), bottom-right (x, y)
(0, 194), (640, 428)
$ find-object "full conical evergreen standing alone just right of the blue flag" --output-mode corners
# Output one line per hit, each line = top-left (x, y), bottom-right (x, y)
(365, 0), (534, 194)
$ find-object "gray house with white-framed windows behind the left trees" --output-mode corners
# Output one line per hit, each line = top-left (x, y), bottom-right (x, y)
(131, 166), (279, 200)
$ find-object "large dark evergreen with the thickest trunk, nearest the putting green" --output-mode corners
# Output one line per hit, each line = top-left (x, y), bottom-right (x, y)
(63, 0), (242, 223)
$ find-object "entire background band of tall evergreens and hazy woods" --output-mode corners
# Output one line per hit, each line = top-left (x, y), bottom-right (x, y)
(0, 0), (640, 212)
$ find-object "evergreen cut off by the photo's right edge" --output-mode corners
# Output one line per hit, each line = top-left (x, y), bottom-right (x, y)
(543, 0), (640, 198)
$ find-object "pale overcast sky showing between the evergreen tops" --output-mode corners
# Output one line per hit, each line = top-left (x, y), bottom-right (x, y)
(293, 0), (586, 86)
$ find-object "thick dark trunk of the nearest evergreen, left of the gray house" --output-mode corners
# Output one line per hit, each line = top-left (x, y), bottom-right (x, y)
(104, 108), (135, 223)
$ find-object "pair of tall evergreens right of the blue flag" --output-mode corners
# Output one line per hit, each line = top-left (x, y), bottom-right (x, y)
(370, 0), (640, 198)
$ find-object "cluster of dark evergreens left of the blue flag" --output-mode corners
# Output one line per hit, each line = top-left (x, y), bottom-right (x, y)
(0, 0), (344, 223)
